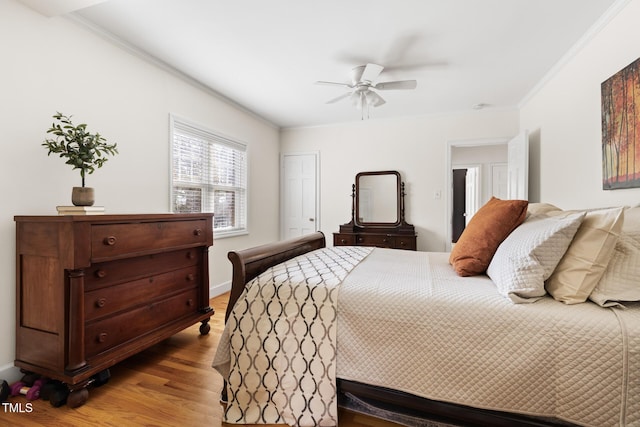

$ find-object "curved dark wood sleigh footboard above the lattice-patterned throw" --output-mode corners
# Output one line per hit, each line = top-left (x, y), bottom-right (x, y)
(224, 231), (326, 322)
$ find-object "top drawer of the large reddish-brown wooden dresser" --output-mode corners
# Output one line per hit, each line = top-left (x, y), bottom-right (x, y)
(91, 220), (207, 262)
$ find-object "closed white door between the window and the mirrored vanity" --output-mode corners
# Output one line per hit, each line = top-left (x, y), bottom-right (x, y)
(281, 153), (319, 239)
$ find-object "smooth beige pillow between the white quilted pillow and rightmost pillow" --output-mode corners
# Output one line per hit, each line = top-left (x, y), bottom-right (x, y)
(545, 207), (624, 304)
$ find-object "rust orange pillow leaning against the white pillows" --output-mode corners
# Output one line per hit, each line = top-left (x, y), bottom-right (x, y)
(449, 197), (529, 276)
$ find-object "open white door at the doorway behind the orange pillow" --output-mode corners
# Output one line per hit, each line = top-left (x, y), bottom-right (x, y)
(507, 130), (529, 200)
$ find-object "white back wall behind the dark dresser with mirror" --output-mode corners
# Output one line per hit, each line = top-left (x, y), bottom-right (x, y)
(281, 110), (518, 251)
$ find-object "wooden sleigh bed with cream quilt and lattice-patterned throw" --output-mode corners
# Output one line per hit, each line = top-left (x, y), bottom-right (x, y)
(214, 201), (640, 427)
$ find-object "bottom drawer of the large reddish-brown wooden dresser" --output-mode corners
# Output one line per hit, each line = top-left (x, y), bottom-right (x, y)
(85, 288), (198, 358)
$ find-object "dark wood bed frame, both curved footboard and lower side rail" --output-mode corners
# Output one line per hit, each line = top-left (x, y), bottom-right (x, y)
(223, 232), (573, 427)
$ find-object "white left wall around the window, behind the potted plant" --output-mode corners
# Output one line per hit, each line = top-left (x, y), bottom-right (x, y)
(0, 0), (279, 380)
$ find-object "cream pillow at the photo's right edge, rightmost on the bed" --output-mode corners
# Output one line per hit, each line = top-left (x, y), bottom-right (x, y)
(589, 207), (640, 307)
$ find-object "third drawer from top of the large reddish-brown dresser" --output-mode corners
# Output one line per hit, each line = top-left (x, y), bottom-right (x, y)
(84, 266), (200, 321)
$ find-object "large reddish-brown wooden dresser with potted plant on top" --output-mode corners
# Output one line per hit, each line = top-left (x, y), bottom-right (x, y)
(15, 214), (213, 407)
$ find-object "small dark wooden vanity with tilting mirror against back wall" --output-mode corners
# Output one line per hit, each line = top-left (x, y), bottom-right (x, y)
(333, 171), (417, 251)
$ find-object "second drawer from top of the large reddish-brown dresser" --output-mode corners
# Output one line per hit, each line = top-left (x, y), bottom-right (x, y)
(84, 247), (203, 291)
